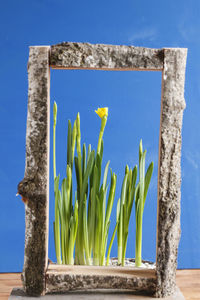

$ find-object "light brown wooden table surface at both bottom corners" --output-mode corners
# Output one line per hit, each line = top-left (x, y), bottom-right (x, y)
(0, 269), (200, 300)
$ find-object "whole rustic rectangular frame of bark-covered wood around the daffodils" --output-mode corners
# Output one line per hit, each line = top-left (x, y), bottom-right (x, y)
(18, 43), (187, 297)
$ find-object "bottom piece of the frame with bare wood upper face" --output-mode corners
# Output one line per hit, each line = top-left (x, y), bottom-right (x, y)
(46, 265), (156, 294)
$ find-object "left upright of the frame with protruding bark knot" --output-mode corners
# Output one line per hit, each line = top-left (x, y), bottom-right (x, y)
(18, 47), (50, 296)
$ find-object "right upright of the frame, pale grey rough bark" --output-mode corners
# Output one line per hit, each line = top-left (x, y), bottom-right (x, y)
(156, 49), (187, 297)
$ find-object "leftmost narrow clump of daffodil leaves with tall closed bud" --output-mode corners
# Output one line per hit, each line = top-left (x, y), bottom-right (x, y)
(53, 103), (78, 264)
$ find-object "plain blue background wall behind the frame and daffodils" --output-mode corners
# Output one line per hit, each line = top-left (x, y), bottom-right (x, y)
(0, 0), (200, 272)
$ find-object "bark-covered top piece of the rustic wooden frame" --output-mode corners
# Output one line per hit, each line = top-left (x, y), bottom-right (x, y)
(50, 42), (163, 70)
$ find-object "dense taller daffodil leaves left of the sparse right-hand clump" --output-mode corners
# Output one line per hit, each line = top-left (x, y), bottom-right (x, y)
(53, 103), (116, 265)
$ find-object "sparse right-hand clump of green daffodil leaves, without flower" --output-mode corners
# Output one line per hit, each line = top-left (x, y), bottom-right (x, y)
(106, 140), (153, 267)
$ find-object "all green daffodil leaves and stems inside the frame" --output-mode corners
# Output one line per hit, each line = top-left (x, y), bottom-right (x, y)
(53, 103), (153, 266)
